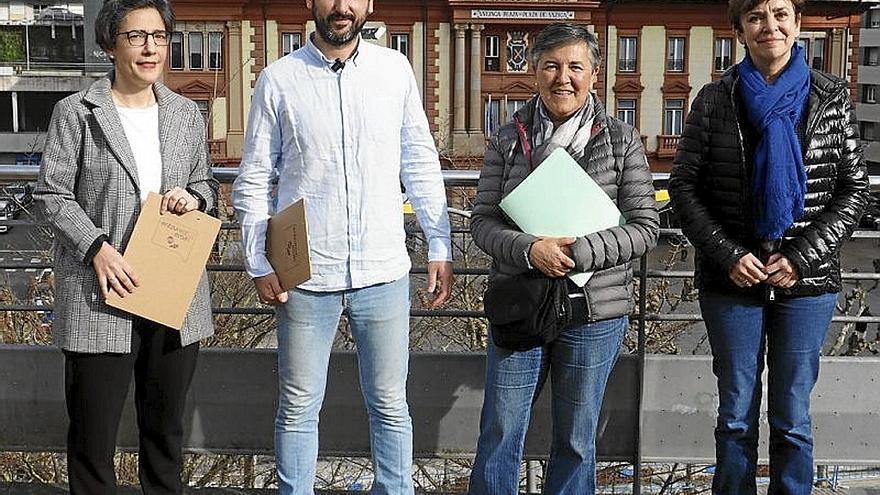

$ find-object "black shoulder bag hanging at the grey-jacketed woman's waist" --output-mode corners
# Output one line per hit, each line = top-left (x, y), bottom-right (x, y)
(483, 270), (571, 351)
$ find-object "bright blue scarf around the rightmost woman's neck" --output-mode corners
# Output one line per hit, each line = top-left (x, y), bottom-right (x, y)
(737, 45), (810, 240)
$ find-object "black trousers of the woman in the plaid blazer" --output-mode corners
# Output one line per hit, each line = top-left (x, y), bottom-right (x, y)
(64, 318), (199, 495)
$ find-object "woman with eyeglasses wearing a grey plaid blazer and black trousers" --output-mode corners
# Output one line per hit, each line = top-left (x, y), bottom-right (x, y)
(34, 0), (217, 495)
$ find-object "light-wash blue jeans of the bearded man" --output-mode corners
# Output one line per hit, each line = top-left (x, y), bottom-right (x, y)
(275, 277), (413, 495)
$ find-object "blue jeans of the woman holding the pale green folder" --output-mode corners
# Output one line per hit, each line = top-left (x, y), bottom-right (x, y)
(468, 317), (627, 495)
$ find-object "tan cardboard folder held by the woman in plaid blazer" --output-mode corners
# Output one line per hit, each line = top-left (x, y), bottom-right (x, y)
(107, 193), (221, 330)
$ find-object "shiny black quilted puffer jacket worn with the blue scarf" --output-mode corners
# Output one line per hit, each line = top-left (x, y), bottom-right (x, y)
(669, 67), (868, 296)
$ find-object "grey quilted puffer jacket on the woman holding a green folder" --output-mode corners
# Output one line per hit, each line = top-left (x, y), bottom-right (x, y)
(471, 97), (660, 321)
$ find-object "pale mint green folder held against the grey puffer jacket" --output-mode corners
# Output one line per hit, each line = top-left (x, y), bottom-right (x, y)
(501, 148), (626, 287)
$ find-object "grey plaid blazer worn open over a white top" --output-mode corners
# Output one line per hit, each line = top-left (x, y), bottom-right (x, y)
(34, 72), (217, 353)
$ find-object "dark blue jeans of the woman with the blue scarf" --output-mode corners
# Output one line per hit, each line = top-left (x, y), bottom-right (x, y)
(700, 291), (837, 495)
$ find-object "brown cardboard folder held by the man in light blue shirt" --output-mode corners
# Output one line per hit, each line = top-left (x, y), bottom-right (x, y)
(266, 199), (312, 290)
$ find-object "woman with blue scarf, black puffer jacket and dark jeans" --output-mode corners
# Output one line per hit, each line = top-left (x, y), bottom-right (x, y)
(669, 0), (868, 495)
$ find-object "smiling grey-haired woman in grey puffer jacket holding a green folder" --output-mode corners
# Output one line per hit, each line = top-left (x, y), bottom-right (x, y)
(470, 24), (659, 495)
